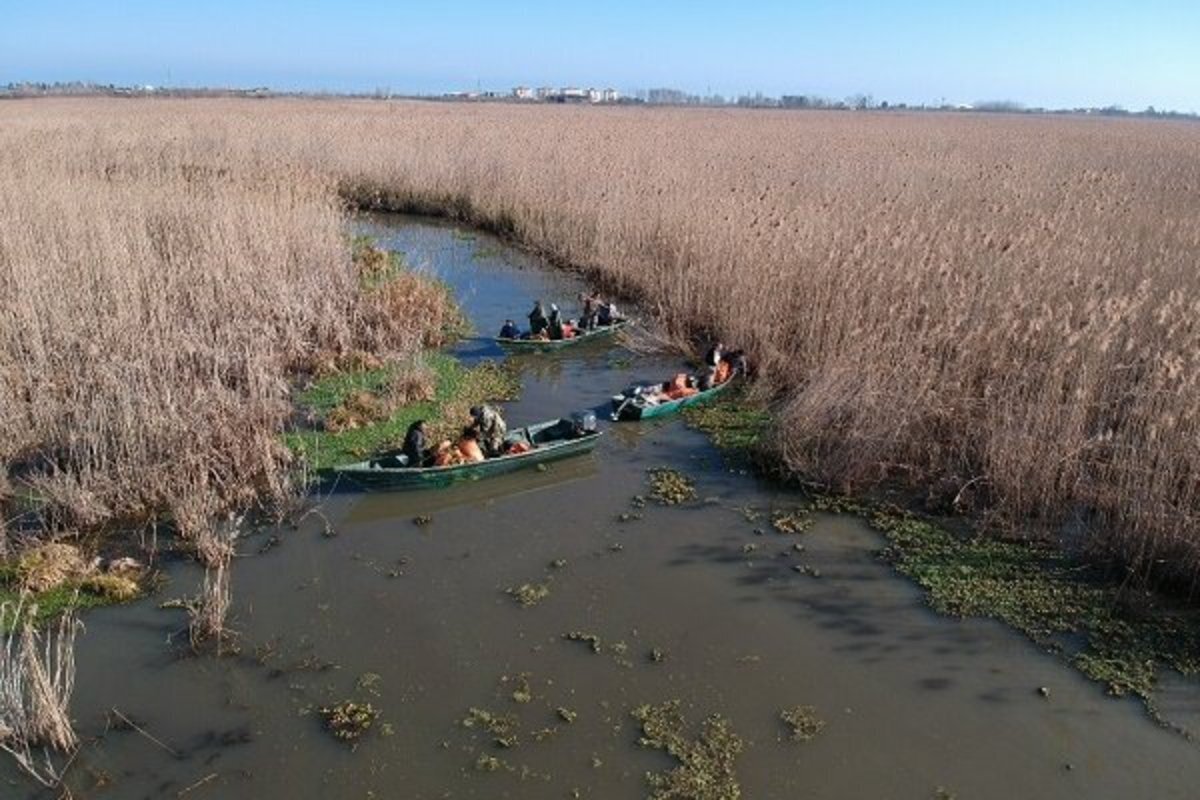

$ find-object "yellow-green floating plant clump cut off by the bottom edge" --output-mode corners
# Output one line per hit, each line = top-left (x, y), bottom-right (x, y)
(631, 700), (743, 800)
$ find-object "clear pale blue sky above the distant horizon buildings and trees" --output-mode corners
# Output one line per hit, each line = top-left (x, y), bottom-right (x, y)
(0, 0), (1200, 112)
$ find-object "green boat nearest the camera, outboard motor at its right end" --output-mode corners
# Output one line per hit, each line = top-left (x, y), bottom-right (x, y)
(330, 417), (600, 489)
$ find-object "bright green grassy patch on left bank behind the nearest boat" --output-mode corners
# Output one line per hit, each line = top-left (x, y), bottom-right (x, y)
(284, 353), (520, 470)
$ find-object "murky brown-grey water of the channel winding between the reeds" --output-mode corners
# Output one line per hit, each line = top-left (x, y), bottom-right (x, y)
(11, 218), (1200, 800)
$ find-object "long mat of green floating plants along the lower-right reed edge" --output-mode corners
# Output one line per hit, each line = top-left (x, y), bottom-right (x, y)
(870, 510), (1200, 716)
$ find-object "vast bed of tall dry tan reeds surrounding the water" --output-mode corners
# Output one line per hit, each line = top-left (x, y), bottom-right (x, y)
(0, 101), (1200, 581)
